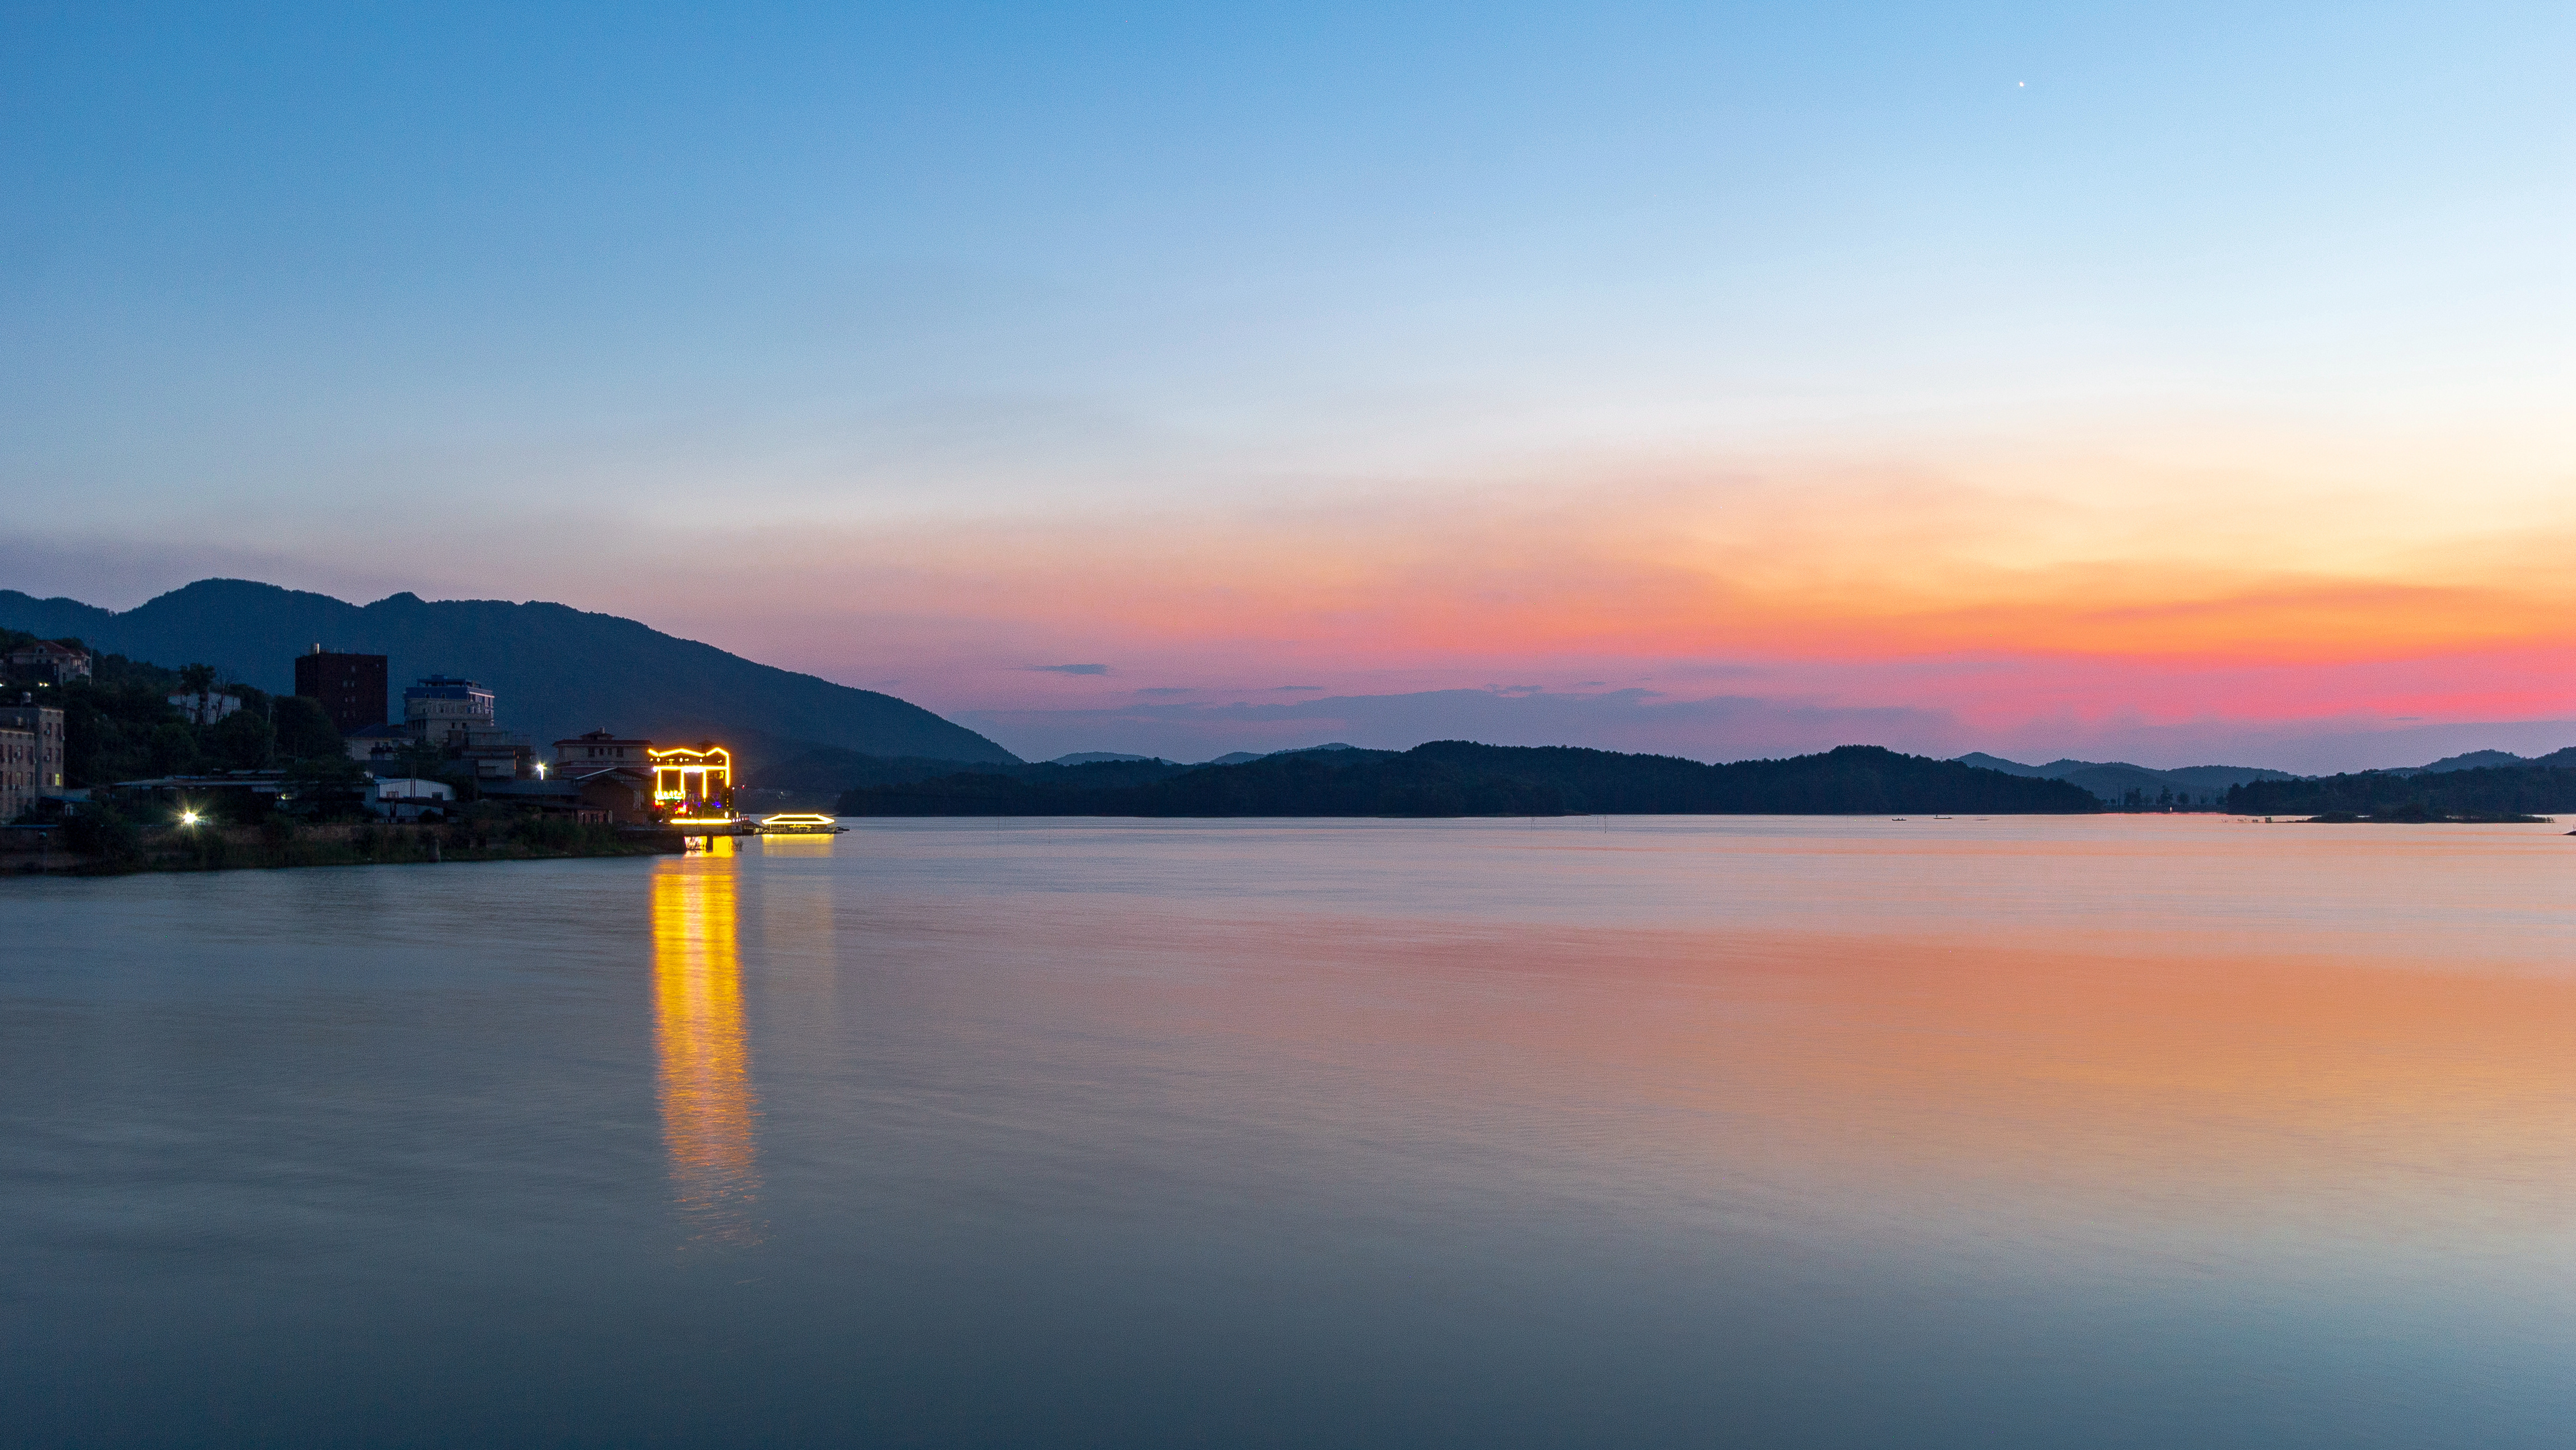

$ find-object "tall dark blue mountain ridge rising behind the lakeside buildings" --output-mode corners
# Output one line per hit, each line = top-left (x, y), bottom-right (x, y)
(0, 580), (1018, 765)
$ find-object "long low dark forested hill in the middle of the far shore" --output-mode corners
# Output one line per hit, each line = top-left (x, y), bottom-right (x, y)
(840, 739), (2099, 817)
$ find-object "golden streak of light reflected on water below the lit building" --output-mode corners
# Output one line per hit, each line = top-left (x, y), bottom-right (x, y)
(652, 863), (760, 1244)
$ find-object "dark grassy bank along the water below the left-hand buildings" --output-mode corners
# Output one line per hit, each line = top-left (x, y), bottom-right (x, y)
(0, 819), (680, 876)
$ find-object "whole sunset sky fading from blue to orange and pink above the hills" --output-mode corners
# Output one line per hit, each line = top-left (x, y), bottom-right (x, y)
(0, 3), (2576, 770)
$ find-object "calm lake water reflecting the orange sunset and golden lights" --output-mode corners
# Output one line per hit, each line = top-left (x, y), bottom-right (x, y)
(0, 817), (2576, 1447)
